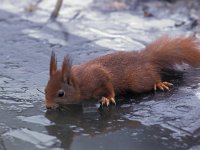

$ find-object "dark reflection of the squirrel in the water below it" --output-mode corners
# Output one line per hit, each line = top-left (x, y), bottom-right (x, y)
(45, 105), (140, 149)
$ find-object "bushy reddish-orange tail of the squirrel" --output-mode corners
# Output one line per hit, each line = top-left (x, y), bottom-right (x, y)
(144, 36), (200, 69)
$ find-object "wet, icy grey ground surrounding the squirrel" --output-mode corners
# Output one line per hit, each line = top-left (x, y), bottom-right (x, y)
(0, 0), (200, 150)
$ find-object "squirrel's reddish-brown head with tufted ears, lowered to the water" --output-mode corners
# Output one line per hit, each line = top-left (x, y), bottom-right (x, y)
(45, 52), (80, 109)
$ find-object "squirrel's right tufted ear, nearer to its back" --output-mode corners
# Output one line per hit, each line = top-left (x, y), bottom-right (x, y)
(62, 55), (72, 84)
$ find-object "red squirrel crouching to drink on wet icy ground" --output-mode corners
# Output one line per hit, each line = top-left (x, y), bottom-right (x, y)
(45, 36), (200, 109)
